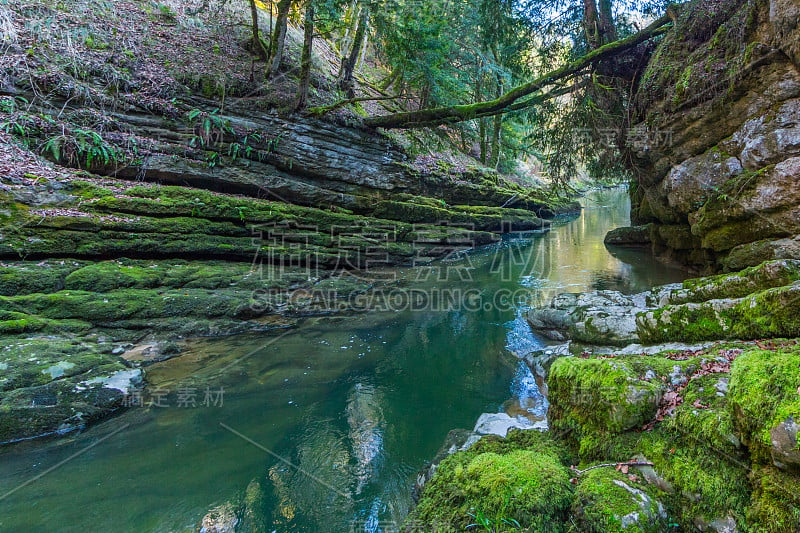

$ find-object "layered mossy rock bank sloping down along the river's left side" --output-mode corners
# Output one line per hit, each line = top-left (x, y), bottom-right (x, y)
(0, 0), (579, 444)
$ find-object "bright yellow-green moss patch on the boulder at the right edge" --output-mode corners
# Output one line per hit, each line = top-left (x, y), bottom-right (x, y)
(730, 345), (800, 464)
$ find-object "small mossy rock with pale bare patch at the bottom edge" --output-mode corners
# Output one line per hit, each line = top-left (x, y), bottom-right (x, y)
(573, 468), (667, 533)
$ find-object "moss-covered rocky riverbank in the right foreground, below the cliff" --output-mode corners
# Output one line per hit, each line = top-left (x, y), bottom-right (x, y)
(410, 260), (800, 533)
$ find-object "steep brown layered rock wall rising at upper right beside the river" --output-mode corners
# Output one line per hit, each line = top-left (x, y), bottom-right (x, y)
(615, 0), (800, 270)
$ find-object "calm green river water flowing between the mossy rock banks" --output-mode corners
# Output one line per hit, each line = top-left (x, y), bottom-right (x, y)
(0, 190), (685, 532)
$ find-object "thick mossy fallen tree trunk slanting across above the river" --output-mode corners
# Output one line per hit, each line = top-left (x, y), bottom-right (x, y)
(364, 15), (672, 129)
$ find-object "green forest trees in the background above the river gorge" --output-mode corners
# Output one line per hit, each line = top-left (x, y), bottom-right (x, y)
(252, 0), (671, 181)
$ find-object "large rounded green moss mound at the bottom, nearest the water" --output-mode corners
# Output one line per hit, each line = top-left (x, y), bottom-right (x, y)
(411, 432), (572, 533)
